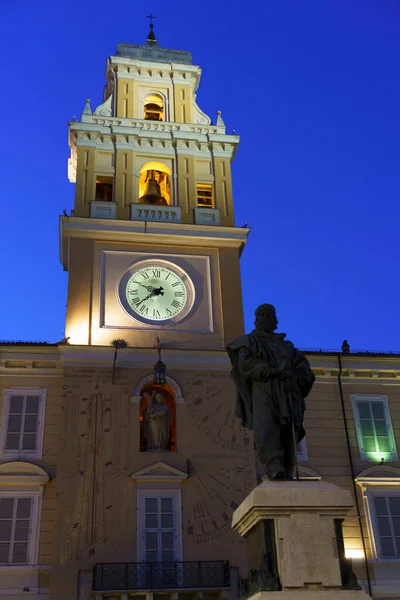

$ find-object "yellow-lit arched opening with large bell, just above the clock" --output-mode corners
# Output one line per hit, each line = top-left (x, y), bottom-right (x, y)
(139, 161), (171, 206)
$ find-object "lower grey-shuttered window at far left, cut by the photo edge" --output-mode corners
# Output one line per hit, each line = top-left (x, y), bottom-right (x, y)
(0, 496), (33, 565)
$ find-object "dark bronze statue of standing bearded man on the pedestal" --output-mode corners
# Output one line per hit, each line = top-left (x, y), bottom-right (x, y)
(227, 304), (315, 480)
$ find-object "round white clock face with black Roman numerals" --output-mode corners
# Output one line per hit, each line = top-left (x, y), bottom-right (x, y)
(119, 260), (194, 324)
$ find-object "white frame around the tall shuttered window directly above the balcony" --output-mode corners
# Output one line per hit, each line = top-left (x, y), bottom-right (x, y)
(137, 488), (183, 562)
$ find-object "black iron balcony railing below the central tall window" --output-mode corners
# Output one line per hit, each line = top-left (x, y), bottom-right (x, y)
(93, 560), (231, 592)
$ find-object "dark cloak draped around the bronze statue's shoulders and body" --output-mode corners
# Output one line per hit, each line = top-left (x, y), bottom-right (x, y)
(227, 330), (315, 441)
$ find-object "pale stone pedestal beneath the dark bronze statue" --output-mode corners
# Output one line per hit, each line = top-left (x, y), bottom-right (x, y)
(232, 481), (369, 600)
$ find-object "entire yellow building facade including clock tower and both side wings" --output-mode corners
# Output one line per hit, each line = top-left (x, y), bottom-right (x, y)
(0, 29), (400, 600)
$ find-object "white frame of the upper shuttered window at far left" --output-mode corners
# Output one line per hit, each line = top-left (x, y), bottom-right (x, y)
(0, 387), (47, 460)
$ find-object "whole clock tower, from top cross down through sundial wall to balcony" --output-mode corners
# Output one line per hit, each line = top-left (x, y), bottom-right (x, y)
(50, 27), (256, 600)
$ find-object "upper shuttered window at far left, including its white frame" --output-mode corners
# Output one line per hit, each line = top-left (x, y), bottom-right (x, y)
(0, 388), (46, 460)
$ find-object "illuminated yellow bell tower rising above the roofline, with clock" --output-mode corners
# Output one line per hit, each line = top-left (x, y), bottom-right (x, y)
(60, 25), (249, 350)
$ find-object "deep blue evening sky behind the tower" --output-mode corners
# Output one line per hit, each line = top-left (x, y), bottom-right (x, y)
(0, 0), (400, 351)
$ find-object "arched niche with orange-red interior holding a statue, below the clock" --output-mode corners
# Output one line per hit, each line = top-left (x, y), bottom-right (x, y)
(140, 382), (176, 452)
